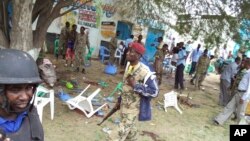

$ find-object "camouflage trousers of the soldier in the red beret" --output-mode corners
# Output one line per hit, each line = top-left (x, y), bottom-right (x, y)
(107, 113), (138, 141)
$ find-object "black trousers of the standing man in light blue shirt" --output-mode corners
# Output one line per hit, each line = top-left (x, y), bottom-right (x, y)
(174, 64), (185, 89)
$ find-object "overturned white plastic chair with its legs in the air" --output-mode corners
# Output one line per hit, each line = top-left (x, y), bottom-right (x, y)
(66, 85), (107, 118)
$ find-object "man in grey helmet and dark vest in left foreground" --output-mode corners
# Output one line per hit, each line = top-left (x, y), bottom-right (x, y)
(0, 49), (44, 141)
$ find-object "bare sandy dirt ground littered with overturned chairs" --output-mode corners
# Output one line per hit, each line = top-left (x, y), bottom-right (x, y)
(42, 55), (234, 141)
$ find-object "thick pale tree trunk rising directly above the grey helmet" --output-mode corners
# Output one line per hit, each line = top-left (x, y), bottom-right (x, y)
(10, 0), (33, 51)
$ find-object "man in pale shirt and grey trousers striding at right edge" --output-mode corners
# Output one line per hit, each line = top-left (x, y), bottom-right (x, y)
(214, 58), (250, 125)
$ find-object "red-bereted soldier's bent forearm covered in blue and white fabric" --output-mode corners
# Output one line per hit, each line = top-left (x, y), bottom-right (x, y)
(134, 75), (159, 97)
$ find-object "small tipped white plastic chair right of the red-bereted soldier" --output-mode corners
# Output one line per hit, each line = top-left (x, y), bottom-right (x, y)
(164, 91), (182, 114)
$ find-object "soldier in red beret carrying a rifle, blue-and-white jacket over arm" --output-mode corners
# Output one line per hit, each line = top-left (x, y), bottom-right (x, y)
(107, 43), (159, 141)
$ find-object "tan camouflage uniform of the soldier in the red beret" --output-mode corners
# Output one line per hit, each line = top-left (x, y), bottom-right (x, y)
(108, 63), (158, 141)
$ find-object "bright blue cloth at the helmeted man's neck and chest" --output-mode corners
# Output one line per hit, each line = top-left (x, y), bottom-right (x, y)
(0, 112), (28, 134)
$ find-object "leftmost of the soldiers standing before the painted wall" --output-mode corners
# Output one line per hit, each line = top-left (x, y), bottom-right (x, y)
(58, 22), (70, 59)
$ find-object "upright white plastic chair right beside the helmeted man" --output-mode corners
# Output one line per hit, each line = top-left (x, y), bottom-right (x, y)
(34, 86), (55, 122)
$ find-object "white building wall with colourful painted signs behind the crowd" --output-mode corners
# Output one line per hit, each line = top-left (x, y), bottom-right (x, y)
(36, 0), (178, 57)
